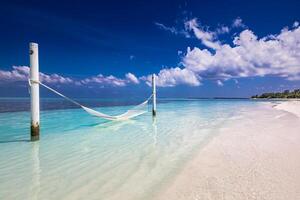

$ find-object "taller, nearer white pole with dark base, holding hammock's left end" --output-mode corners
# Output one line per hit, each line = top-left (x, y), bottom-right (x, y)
(29, 43), (40, 141)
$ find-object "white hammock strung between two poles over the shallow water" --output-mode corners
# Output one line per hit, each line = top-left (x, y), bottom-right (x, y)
(29, 80), (153, 121)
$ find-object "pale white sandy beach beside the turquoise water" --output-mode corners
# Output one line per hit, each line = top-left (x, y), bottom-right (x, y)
(157, 101), (300, 200)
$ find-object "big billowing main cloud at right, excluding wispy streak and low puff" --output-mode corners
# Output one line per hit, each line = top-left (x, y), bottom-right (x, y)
(183, 25), (300, 80)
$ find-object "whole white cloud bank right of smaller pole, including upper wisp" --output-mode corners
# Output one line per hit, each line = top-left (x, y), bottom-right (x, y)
(151, 20), (300, 87)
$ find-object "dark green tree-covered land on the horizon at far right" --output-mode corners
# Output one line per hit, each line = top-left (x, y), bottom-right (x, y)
(251, 89), (300, 99)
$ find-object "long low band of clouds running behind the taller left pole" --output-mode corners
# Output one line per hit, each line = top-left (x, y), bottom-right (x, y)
(0, 66), (139, 87)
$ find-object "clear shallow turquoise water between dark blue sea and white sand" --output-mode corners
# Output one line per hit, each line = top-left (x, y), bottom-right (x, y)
(0, 100), (259, 200)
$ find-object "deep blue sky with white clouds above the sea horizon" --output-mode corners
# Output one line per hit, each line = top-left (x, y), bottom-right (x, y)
(0, 0), (300, 98)
